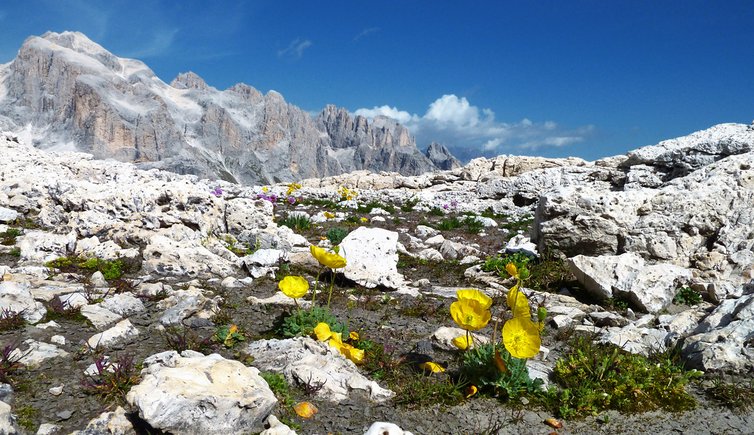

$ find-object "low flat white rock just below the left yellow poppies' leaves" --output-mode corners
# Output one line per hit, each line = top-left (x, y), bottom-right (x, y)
(245, 337), (395, 402)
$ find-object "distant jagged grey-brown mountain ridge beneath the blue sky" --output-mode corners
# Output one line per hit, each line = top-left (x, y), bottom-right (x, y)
(0, 32), (459, 184)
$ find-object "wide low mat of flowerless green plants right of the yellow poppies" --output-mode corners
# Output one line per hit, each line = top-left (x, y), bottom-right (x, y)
(546, 337), (701, 418)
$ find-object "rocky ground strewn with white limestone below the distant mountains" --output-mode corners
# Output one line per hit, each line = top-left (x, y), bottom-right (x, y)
(0, 122), (754, 434)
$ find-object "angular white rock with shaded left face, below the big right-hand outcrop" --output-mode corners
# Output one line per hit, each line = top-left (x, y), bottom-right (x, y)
(568, 253), (691, 313)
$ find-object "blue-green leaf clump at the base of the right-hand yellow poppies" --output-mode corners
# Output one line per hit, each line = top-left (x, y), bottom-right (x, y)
(461, 343), (544, 399)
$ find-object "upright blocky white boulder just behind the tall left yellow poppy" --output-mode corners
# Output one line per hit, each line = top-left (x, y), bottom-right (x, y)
(340, 227), (404, 289)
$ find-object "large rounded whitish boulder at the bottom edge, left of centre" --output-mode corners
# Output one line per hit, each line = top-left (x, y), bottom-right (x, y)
(126, 351), (277, 435)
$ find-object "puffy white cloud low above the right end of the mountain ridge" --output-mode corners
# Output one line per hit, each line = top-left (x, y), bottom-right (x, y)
(354, 94), (594, 160)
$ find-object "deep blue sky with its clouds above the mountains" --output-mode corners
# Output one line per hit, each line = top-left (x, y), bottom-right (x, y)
(0, 0), (754, 160)
